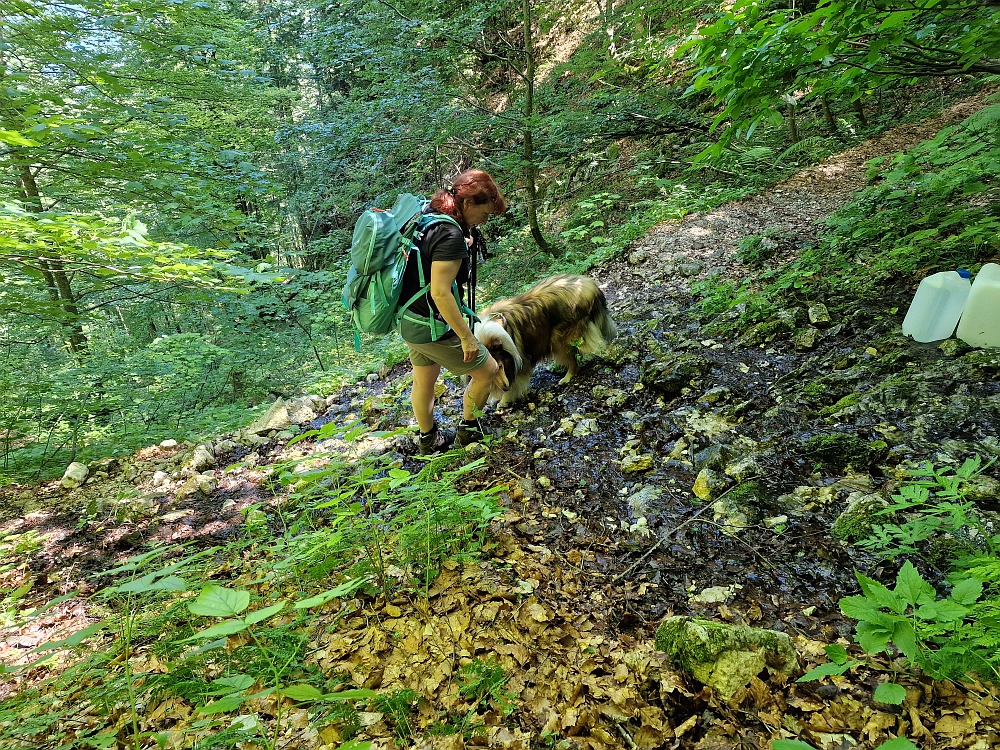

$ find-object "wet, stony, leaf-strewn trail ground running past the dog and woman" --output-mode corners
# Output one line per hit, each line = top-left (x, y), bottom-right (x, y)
(0, 91), (1000, 748)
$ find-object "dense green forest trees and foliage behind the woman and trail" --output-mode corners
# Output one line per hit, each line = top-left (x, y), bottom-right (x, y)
(0, 0), (1000, 482)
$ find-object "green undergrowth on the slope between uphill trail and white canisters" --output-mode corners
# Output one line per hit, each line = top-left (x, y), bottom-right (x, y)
(692, 96), (1000, 333)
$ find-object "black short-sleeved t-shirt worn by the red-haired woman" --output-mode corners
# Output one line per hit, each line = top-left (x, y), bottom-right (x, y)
(399, 214), (469, 344)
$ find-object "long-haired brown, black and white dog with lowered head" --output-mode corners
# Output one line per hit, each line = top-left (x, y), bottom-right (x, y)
(475, 274), (618, 406)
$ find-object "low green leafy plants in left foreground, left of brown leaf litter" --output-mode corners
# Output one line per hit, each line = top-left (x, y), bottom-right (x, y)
(0, 423), (506, 750)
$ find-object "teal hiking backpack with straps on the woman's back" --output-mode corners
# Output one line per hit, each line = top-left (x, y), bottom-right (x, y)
(341, 193), (471, 351)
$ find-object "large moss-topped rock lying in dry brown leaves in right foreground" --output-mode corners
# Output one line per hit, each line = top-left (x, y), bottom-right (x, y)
(656, 616), (798, 702)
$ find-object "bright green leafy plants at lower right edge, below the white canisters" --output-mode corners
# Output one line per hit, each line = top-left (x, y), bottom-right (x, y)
(800, 456), (1000, 704)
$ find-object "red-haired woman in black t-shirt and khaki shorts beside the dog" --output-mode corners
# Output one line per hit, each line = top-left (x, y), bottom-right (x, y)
(399, 169), (507, 455)
